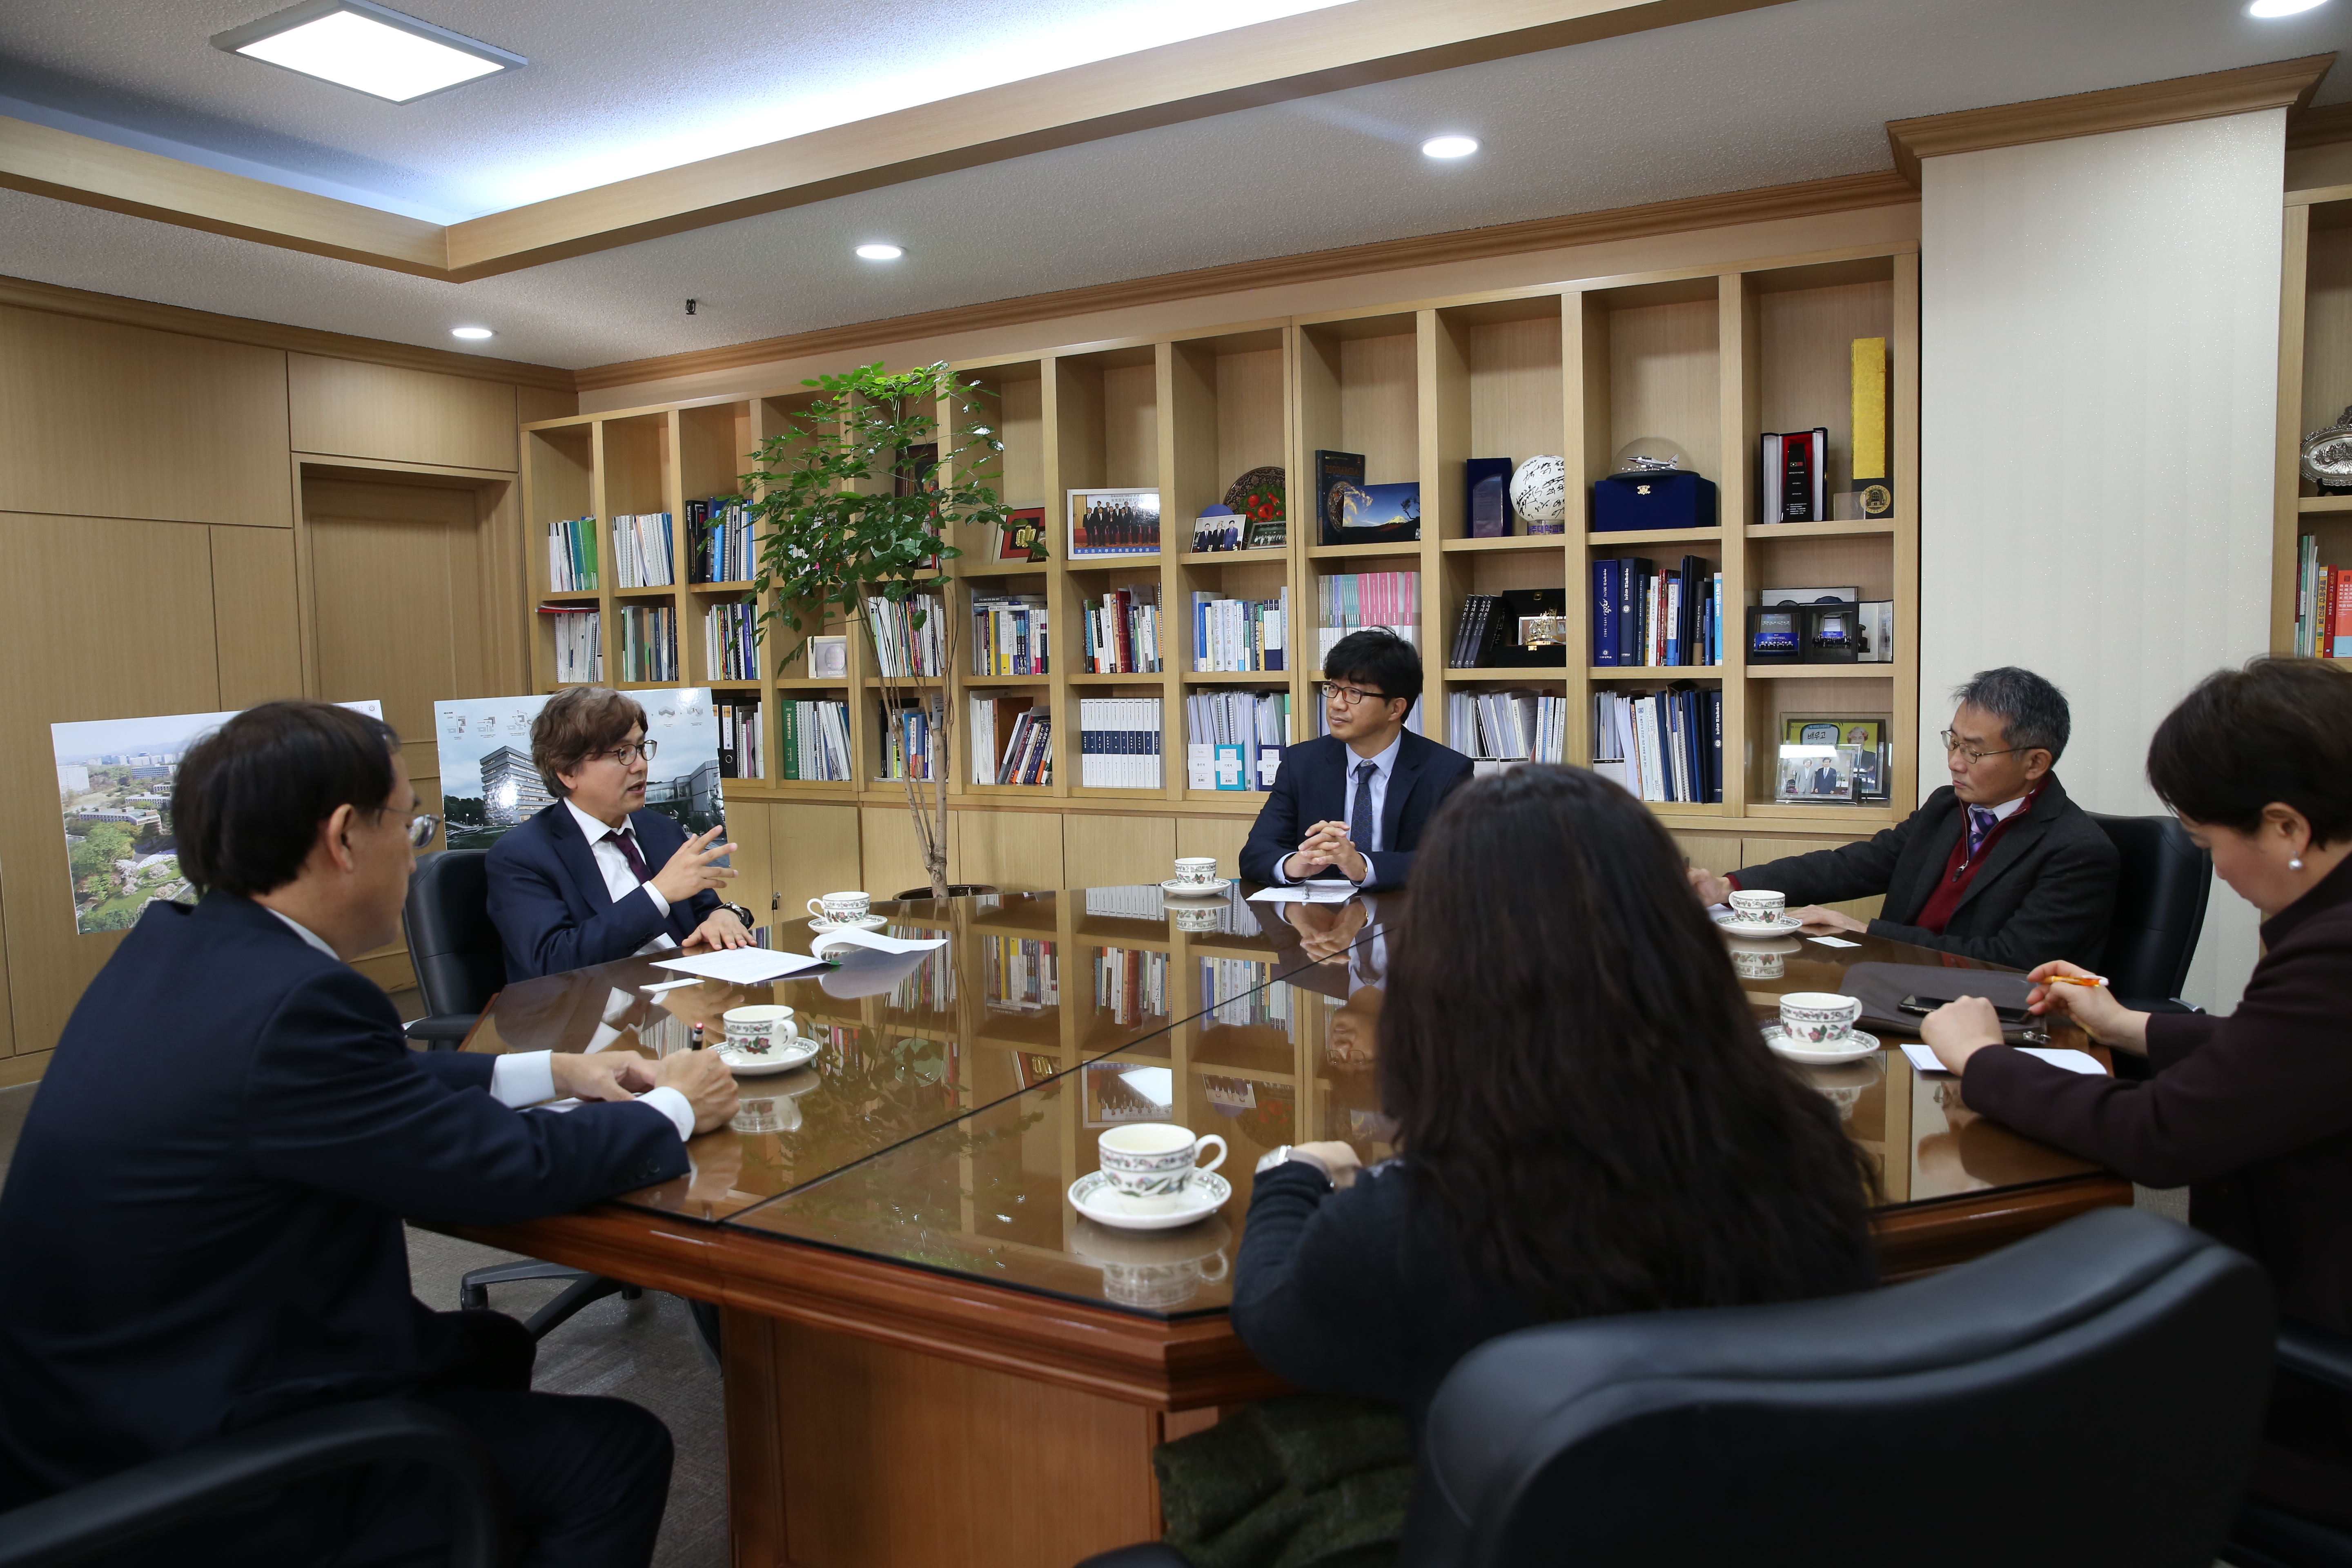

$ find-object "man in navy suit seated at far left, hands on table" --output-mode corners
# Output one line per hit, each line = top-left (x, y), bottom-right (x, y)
(0, 703), (736, 1568)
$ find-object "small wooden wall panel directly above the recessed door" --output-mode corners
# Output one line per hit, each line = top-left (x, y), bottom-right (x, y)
(287, 355), (522, 472)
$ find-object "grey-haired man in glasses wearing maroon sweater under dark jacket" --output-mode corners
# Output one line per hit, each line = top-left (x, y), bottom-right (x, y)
(1691, 668), (2119, 969)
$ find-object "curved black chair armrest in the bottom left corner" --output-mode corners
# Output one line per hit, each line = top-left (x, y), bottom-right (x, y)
(0, 1399), (506, 1568)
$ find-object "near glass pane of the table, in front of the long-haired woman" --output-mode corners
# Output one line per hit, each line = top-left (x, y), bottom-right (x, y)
(729, 921), (2096, 1316)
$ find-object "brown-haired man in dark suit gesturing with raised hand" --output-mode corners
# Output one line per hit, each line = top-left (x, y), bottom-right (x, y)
(487, 686), (753, 980)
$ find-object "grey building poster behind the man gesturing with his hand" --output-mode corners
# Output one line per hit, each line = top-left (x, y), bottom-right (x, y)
(433, 686), (727, 849)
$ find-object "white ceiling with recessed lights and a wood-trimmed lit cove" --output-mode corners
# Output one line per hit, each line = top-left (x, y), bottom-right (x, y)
(0, 0), (2352, 367)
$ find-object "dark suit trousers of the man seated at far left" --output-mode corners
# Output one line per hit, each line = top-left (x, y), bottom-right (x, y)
(134, 1312), (670, 1568)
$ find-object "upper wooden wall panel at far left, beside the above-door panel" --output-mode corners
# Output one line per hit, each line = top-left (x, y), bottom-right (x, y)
(0, 308), (294, 529)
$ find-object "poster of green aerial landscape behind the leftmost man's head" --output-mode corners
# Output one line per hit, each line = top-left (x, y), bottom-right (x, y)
(49, 701), (383, 935)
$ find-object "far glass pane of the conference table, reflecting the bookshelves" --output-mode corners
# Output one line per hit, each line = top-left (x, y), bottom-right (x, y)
(466, 886), (1362, 1220)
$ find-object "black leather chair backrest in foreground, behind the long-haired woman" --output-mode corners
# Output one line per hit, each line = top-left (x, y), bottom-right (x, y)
(1399, 1208), (2272, 1568)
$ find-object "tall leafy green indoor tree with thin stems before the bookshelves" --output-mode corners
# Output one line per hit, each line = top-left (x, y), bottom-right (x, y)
(743, 364), (1004, 898)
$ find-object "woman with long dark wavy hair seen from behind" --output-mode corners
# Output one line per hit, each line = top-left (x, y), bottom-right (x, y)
(1232, 766), (1875, 1425)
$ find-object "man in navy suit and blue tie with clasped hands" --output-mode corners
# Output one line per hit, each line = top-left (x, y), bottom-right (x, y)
(1242, 628), (1470, 891)
